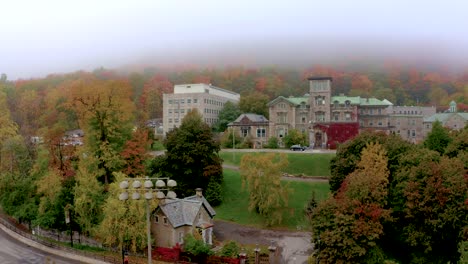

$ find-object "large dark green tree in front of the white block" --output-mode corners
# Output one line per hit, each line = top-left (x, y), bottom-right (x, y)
(150, 110), (223, 203)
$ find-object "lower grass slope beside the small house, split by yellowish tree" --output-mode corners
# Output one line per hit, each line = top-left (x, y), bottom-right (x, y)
(215, 169), (329, 230)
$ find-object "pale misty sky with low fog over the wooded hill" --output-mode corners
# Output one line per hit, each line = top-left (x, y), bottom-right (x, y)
(0, 0), (468, 80)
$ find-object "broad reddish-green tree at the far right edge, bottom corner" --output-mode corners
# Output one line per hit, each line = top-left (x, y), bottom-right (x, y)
(388, 149), (468, 263)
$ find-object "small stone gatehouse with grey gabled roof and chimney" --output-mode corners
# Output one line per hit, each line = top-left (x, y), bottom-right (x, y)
(151, 188), (216, 247)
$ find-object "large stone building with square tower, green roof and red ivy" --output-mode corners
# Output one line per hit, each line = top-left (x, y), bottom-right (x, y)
(268, 77), (392, 148)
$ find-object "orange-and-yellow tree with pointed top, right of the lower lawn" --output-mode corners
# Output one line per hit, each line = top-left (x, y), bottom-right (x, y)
(312, 143), (390, 263)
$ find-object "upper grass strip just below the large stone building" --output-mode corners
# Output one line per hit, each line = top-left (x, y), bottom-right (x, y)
(219, 151), (335, 177)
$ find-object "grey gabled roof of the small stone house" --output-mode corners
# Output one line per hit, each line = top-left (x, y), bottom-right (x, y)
(158, 199), (202, 228)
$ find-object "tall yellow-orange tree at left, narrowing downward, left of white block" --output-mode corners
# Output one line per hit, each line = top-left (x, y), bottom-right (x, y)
(70, 79), (135, 184)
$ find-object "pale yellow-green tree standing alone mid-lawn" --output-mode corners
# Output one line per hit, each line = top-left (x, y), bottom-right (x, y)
(240, 153), (290, 226)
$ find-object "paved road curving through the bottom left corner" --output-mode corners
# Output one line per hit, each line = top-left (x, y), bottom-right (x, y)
(0, 229), (82, 264)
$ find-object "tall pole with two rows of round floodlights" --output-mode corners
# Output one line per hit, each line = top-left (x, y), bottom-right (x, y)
(119, 177), (177, 264)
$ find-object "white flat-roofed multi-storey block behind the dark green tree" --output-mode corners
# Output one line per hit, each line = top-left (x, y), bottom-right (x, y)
(163, 83), (240, 135)
